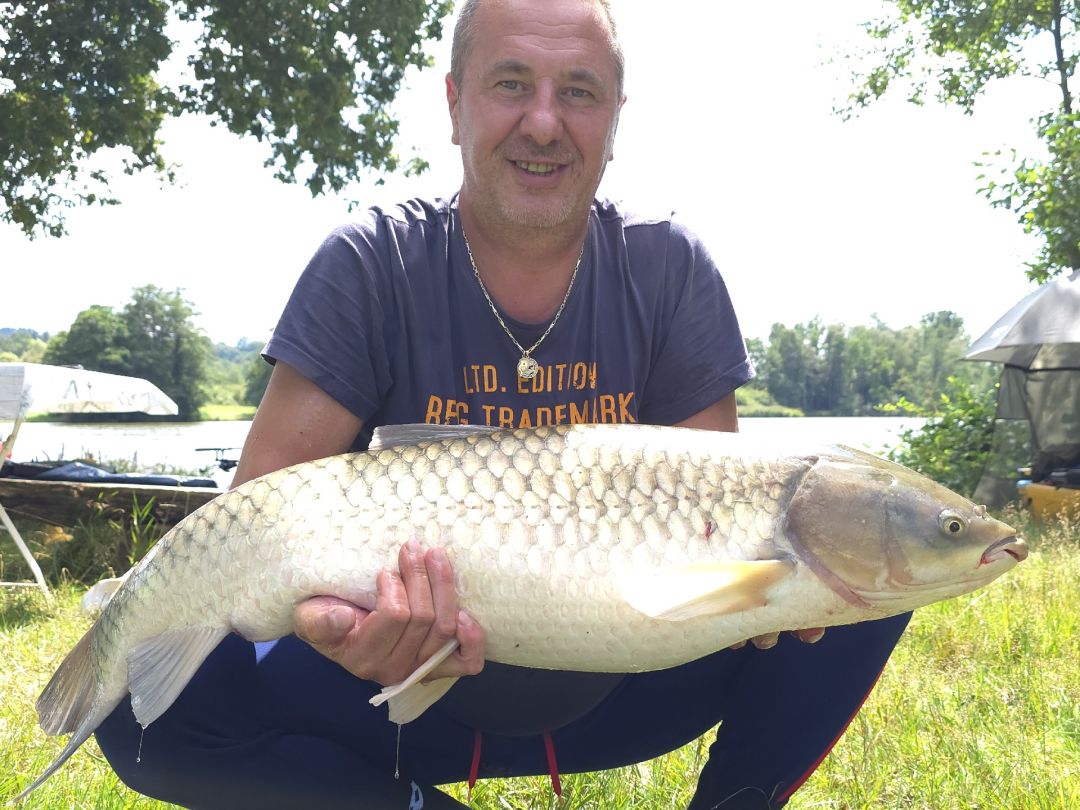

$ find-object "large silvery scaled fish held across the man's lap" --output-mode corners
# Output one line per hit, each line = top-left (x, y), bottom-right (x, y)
(21, 426), (1027, 797)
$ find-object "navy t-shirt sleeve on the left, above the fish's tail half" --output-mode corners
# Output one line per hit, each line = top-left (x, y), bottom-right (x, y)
(262, 222), (391, 421)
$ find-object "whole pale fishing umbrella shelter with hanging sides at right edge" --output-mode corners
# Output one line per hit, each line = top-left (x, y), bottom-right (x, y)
(964, 270), (1080, 505)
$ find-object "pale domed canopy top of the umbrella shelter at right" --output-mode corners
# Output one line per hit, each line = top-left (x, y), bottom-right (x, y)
(963, 270), (1080, 370)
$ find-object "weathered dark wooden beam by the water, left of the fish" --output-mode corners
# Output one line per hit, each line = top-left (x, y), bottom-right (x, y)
(0, 478), (221, 530)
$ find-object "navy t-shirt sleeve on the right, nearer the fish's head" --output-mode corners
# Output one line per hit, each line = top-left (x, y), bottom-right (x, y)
(640, 221), (754, 424)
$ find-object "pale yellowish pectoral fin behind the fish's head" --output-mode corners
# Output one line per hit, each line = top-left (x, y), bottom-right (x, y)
(619, 559), (795, 622)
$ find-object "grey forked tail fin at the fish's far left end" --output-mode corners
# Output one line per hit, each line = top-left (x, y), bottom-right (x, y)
(10, 631), (120, 804)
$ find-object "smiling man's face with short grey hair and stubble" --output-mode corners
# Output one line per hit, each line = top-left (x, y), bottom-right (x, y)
(446, 0), (622, 234)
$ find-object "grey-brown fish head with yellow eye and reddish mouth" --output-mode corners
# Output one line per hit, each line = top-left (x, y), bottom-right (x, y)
(785, 448), (1027, 613)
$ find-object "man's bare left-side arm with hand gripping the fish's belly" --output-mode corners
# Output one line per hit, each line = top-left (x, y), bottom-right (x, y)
(241, 363), (484, 686)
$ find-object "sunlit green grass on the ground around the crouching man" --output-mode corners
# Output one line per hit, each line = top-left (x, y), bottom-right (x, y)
(0, 509), (1080, 810)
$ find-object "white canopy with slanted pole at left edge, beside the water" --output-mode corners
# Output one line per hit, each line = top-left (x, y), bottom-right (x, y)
(0, 363), (177, 595)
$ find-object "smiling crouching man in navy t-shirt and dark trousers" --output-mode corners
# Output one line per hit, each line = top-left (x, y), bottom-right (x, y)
(98, 0), (904, 810)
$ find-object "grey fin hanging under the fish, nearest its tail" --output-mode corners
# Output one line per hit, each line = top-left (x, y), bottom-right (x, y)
(127, 626), (229, 728)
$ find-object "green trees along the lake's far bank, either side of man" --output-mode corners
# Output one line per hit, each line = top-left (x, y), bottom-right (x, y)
(6, 302), (997, 420)
